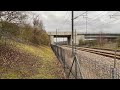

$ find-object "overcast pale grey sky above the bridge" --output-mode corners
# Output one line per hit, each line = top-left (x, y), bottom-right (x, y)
(32, 11), (120, 33)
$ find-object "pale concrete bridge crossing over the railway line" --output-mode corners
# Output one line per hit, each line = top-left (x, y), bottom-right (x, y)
(48, 32), (120, 45)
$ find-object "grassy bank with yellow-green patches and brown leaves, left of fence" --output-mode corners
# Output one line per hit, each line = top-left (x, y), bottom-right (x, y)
(0, 40), (64, 79)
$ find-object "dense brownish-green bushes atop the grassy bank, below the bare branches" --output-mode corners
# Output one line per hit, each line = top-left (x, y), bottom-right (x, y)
(0, 22), (50, 45)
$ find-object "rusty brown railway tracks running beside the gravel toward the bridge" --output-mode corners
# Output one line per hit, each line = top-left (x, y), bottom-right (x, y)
(62, 46), (120, 59)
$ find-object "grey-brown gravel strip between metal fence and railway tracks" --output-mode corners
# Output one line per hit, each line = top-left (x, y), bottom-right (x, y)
(62, 47), (120, 79)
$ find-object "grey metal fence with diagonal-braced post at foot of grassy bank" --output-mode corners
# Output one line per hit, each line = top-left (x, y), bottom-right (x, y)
(51, 45), (82, 79)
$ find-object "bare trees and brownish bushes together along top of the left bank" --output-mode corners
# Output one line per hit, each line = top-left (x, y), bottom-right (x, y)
(0, 11), (50, 45)
